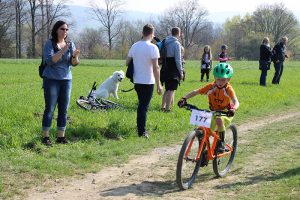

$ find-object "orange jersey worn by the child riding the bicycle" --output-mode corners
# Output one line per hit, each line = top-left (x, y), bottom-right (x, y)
(198, 82), (235, 110)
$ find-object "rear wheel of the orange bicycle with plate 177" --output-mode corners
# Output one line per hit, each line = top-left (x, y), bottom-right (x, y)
(213, 125), (237, 177)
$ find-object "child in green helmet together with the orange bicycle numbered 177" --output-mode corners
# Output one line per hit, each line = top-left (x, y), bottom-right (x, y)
(176, 63), (239, 189)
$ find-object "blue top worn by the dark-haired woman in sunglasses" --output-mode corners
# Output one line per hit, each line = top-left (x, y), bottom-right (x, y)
(43, 39), (76, 80)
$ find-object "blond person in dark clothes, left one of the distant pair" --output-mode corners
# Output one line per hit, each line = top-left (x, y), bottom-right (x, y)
(259, 37), (272, 86)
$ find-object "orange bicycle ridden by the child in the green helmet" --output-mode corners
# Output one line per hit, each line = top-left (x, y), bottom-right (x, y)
(176, 104), (237, 190)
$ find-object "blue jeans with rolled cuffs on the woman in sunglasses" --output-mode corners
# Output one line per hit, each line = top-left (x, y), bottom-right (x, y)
(42, 79), (72, 131)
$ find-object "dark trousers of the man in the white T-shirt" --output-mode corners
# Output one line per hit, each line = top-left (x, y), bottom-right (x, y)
(134, 84), (154, 136)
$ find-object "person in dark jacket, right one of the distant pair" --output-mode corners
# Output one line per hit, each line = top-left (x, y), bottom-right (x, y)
(272, 36), (288, 84)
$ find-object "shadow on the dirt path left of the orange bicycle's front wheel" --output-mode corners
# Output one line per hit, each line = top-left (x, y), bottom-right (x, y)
(100, 181), (180, 197)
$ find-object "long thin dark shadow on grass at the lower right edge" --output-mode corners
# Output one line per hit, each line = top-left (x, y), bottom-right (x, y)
(214, 167), (300, 189)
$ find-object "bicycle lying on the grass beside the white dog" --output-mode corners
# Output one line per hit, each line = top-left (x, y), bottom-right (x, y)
(76, 82), (122, 111)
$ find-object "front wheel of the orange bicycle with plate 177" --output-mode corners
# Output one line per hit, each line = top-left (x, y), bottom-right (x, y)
(176, 130), (205, 190)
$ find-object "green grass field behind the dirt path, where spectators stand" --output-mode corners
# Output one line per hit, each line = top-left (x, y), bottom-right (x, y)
(0, 60), (300, 198)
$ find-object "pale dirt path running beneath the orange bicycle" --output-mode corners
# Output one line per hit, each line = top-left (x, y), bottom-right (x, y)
(22, 112), (300, 200)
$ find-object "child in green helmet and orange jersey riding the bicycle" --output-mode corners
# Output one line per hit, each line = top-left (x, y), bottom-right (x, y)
(178, 63), (239, 152)
